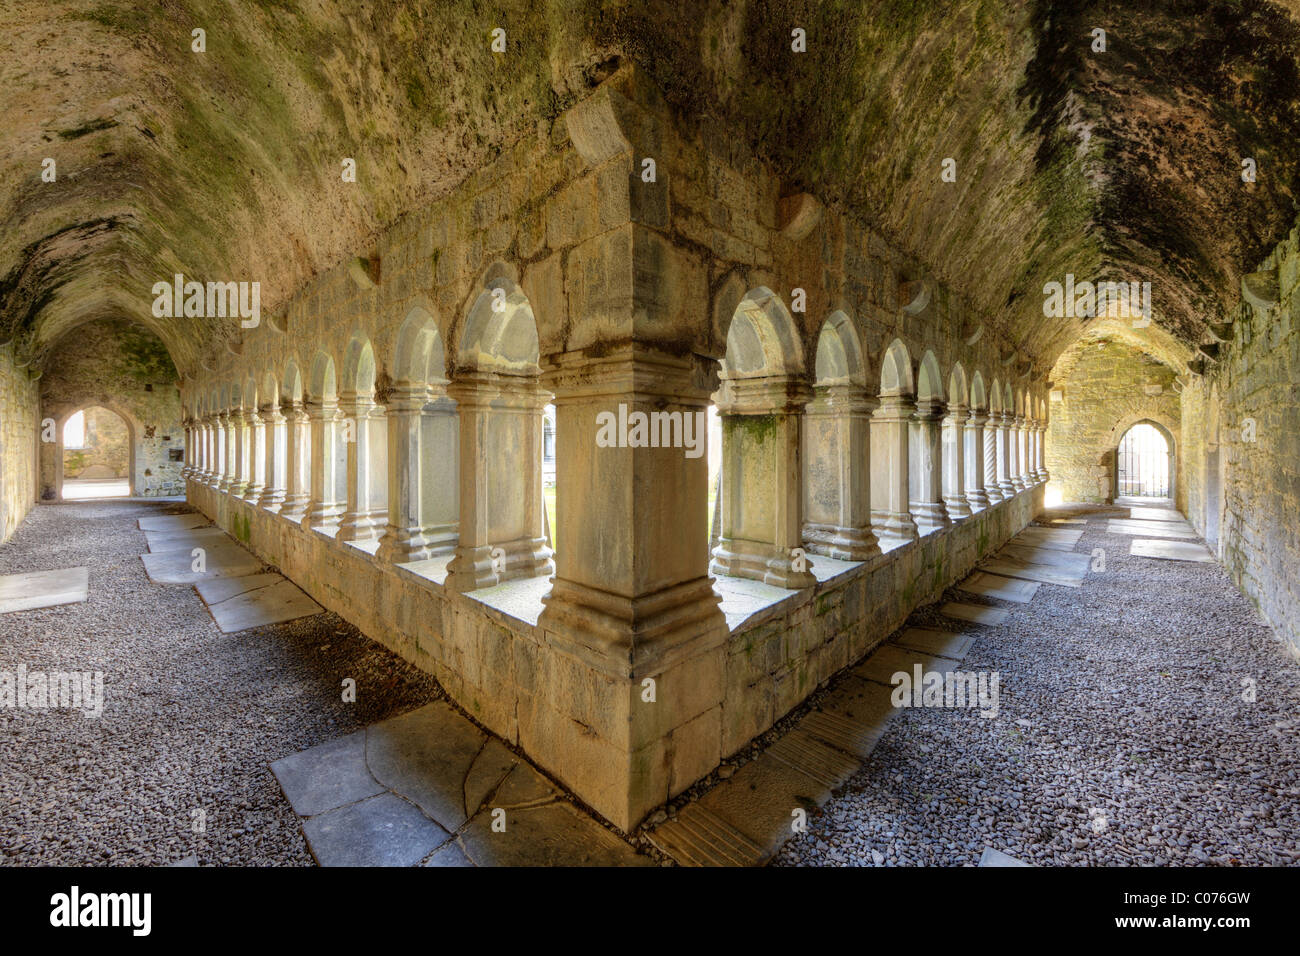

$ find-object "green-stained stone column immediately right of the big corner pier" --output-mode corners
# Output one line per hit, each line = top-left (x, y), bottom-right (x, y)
(709, 377), (816, 588)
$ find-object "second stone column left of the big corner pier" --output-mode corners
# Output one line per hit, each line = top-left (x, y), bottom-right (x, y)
(376, 382), (460, 564)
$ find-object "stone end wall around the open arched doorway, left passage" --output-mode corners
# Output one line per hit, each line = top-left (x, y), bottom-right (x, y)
(40, 320), (185, 501)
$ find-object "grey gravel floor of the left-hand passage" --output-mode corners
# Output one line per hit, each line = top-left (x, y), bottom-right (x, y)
(0, 501), (438, 865)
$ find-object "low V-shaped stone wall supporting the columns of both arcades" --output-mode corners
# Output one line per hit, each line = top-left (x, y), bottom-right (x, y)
(187, 480), (1044, 830)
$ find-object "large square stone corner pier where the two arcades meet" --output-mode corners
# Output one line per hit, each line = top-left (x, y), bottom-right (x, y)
(537, 346), (727, 660)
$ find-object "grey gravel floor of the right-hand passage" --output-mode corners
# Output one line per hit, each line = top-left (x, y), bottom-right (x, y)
(777, 509), (1300, 865)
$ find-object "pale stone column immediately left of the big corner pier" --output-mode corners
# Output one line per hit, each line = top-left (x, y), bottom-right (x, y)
(443, 371), (558, 591)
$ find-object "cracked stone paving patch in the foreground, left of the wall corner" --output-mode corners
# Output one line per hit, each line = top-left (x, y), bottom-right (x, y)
(270, 702), (654, 866)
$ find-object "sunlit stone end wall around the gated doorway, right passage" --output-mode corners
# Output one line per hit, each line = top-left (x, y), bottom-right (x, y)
(1045, 338), (1186, 502)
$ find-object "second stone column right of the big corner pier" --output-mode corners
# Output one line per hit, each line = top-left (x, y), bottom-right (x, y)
(803, 385), (880, 561)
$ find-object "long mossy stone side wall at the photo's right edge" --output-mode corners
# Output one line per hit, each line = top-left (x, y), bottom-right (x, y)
(1182, 222), (1300, 653)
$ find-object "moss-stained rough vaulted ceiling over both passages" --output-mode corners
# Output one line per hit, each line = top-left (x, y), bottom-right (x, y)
(0, 0), (1300, 375)
